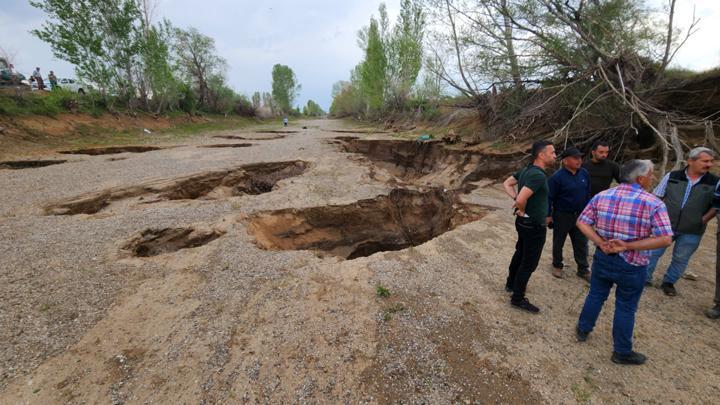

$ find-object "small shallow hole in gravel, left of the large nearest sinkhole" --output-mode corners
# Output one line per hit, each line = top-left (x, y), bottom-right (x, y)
(123, 228), (225, 257)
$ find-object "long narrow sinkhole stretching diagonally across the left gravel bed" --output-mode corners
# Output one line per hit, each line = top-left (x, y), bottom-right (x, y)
(45, 160), (309, 215)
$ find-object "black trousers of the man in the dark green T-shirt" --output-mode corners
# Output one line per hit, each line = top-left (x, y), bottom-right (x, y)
(506, 217), (547, 302)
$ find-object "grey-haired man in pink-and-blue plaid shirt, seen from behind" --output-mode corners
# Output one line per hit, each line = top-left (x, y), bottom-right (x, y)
(575, 160), (672, 364)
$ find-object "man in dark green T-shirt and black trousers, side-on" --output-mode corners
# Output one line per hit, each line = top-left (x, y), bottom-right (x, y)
(503, 141), (555, 314)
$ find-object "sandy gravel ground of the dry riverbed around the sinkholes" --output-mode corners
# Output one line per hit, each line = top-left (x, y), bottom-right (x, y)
(0, 120), (720, 404)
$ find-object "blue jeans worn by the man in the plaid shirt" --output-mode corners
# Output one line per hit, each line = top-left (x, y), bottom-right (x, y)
(578, 249), (647, 354)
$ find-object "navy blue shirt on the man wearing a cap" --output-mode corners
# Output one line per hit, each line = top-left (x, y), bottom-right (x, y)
(548, 167), (590, 214)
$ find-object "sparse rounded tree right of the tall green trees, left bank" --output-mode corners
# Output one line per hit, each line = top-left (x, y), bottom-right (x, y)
(173, 27), (227, 106)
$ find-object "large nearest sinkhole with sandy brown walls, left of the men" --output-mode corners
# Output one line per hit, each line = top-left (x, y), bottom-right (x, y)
(248, 189), (488, 259)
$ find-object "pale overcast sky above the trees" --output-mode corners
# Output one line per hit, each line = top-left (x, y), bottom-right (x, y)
(0, 0), (720, 110)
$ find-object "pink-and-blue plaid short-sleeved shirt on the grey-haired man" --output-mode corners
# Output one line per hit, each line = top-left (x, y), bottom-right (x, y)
(578, 184), (672, 266)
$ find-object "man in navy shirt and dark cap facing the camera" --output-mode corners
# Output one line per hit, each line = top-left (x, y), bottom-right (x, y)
(548, 147), (591, 281)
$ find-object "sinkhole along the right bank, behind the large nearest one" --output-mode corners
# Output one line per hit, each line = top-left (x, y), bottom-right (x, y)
(330, 136), (525, 188)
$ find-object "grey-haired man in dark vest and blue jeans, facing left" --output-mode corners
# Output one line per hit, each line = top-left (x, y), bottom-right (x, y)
(645, 147), (720, 297)
